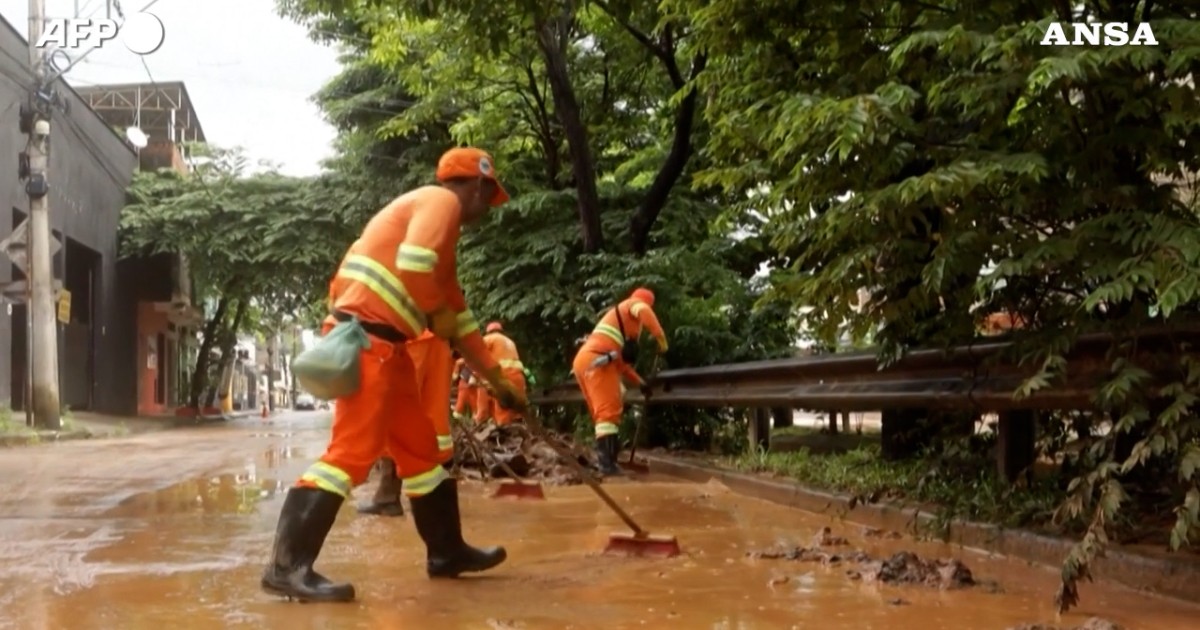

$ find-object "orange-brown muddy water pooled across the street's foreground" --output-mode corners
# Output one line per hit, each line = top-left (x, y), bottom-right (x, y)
(2, 475), (1200, 630)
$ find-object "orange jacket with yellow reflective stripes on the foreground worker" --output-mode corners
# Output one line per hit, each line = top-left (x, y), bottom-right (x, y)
(329, 186), (497, 370)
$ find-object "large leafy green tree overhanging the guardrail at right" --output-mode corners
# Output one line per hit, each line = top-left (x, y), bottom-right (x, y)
(666, 0), (1200, 610)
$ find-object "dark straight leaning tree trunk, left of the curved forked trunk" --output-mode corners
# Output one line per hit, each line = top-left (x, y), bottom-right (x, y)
(538, 14), (604, 253)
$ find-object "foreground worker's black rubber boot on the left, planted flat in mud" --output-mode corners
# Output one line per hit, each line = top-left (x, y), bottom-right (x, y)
(262, 487), (354, 601)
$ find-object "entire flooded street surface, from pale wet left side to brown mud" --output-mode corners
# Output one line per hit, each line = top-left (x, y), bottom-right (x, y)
(0, 413), (1200, 630)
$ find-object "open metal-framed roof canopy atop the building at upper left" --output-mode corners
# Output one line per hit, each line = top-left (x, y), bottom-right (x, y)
(74, 80), (206, 144)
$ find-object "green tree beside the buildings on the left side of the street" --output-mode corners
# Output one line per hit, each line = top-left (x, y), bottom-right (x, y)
(120, 146), (343, 407)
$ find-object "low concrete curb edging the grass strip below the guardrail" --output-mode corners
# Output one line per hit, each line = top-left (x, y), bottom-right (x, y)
(646, 454), (1200, 601)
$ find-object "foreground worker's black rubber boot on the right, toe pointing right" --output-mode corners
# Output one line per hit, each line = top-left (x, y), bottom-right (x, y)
(409, 479), (508, 577)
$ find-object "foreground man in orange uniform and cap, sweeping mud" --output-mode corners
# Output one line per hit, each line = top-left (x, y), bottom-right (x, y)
(262, 149), (526, 601)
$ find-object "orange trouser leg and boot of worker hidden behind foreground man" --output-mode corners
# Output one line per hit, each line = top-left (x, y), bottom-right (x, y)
(359, 330), (454, 516)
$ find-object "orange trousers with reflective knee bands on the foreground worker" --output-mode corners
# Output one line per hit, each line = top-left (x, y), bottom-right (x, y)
(296, 324), (449, 497)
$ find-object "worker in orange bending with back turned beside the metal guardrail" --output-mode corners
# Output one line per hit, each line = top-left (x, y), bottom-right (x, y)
(572, 288), (667, 476)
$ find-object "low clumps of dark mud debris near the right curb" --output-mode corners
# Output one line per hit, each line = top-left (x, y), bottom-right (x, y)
(748, 527), (977, 589)
